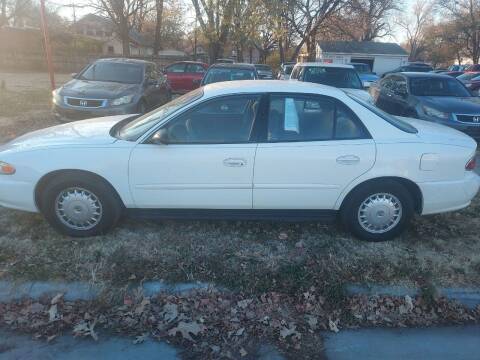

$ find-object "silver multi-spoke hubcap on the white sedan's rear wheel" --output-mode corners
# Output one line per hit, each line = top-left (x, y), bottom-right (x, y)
(358, 193), (402, 234)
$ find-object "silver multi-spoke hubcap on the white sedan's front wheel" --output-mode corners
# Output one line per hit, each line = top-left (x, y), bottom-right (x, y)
(55, 187), (103, 230)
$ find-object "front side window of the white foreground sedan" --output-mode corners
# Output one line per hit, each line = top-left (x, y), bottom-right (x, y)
(165, 95), (260, 144)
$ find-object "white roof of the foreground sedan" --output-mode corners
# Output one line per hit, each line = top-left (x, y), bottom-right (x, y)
(203, 80), (346, 97)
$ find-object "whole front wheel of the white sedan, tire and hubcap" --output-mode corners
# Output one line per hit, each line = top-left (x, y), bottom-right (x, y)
(41, 175), (123, 237)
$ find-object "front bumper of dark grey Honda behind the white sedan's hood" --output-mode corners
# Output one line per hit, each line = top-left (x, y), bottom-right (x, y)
(53, 103), (137, 122)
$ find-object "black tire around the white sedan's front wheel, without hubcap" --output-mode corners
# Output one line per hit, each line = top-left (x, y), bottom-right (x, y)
(39, 173), (124, 237)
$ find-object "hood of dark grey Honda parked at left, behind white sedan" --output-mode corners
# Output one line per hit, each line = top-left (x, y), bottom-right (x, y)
(60, 79), (140, 99)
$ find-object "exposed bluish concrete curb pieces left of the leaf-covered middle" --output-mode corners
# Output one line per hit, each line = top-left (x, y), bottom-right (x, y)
(0, 281), (214, 302)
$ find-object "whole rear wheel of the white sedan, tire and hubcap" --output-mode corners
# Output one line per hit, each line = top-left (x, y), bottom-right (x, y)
(341, 180), (414, 241)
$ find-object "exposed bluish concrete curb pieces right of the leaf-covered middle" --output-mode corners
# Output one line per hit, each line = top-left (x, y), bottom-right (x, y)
(346, 284), (480, 309)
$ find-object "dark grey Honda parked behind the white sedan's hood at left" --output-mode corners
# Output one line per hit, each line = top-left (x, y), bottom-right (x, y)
(52, 58), (172, 122)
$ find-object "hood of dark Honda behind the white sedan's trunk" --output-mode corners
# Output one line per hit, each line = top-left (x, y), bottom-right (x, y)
(417, 96), (480, 115)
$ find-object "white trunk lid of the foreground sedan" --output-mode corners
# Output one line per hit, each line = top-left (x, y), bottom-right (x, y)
(397, 116), (477, 151)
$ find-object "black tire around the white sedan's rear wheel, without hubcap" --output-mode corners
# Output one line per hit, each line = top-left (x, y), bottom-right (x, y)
(340, 180), (414, 242)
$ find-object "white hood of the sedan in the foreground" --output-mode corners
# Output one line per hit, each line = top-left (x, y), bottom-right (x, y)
(0, 114), (132, 152)
